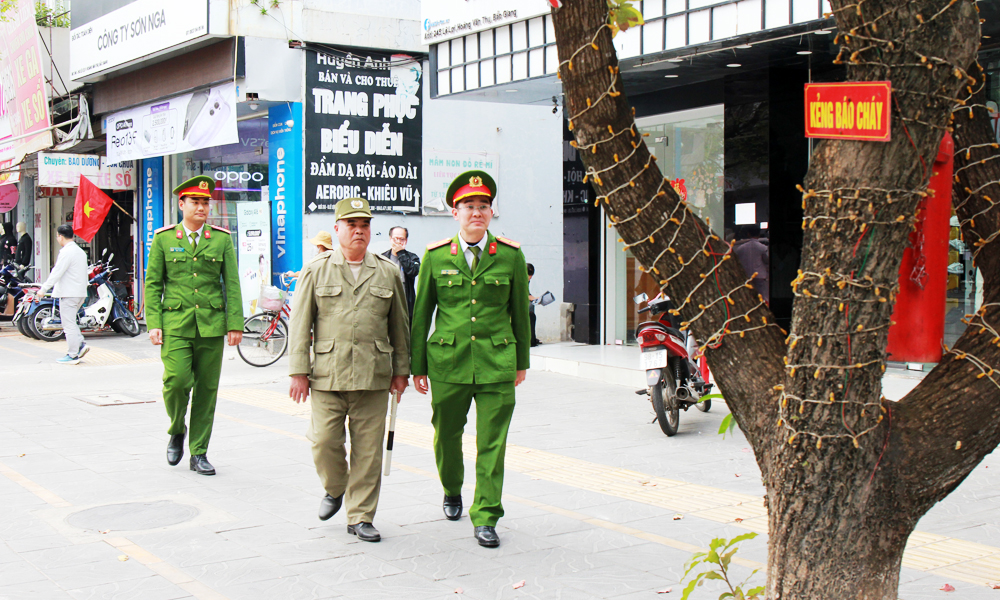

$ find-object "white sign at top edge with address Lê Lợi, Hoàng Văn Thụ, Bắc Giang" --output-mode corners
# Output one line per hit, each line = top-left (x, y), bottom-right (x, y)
(420, 0), (552, 44)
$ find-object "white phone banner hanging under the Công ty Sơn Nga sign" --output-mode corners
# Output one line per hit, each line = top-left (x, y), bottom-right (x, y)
(104, 83), (240, 162)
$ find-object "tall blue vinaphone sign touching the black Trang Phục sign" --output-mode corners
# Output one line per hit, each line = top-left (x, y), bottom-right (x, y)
(267, 102), (302, 286)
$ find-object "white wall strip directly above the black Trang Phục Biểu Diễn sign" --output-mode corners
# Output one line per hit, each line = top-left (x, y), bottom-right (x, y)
(229, 0), (427, 52)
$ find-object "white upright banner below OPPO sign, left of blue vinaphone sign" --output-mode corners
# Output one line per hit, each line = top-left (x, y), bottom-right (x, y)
(236, 202), (271, 318)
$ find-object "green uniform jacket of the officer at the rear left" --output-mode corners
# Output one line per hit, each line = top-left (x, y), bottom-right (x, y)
(146, 224), (243, 337)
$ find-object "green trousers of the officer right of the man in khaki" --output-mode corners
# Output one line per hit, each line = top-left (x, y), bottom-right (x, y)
(431, 380), (514, 527)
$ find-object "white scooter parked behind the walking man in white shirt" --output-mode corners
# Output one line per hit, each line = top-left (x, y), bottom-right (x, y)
(19, 254), (140, 342)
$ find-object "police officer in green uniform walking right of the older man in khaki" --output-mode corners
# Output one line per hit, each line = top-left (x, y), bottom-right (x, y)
(410, 171), (531, 548)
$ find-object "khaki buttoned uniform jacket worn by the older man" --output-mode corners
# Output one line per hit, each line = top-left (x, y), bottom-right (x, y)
(289, 248), (410, 391)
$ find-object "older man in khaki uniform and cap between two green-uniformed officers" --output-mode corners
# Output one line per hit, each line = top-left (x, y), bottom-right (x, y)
(289, 198), (410, 542)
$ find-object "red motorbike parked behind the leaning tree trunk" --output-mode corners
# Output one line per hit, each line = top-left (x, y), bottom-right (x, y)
(634, 294), (712, 436)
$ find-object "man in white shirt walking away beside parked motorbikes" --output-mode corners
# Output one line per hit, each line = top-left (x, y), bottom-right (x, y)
(35, 224), (90, 365)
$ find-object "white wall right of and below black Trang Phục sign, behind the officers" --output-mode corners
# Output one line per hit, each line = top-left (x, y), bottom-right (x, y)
(302, 63), (563, 341)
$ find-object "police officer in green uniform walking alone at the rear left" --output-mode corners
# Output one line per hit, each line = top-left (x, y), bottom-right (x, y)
(146, 175), (243, 475)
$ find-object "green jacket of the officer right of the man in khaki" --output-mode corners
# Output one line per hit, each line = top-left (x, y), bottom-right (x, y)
(410, 232), (531, 383)
